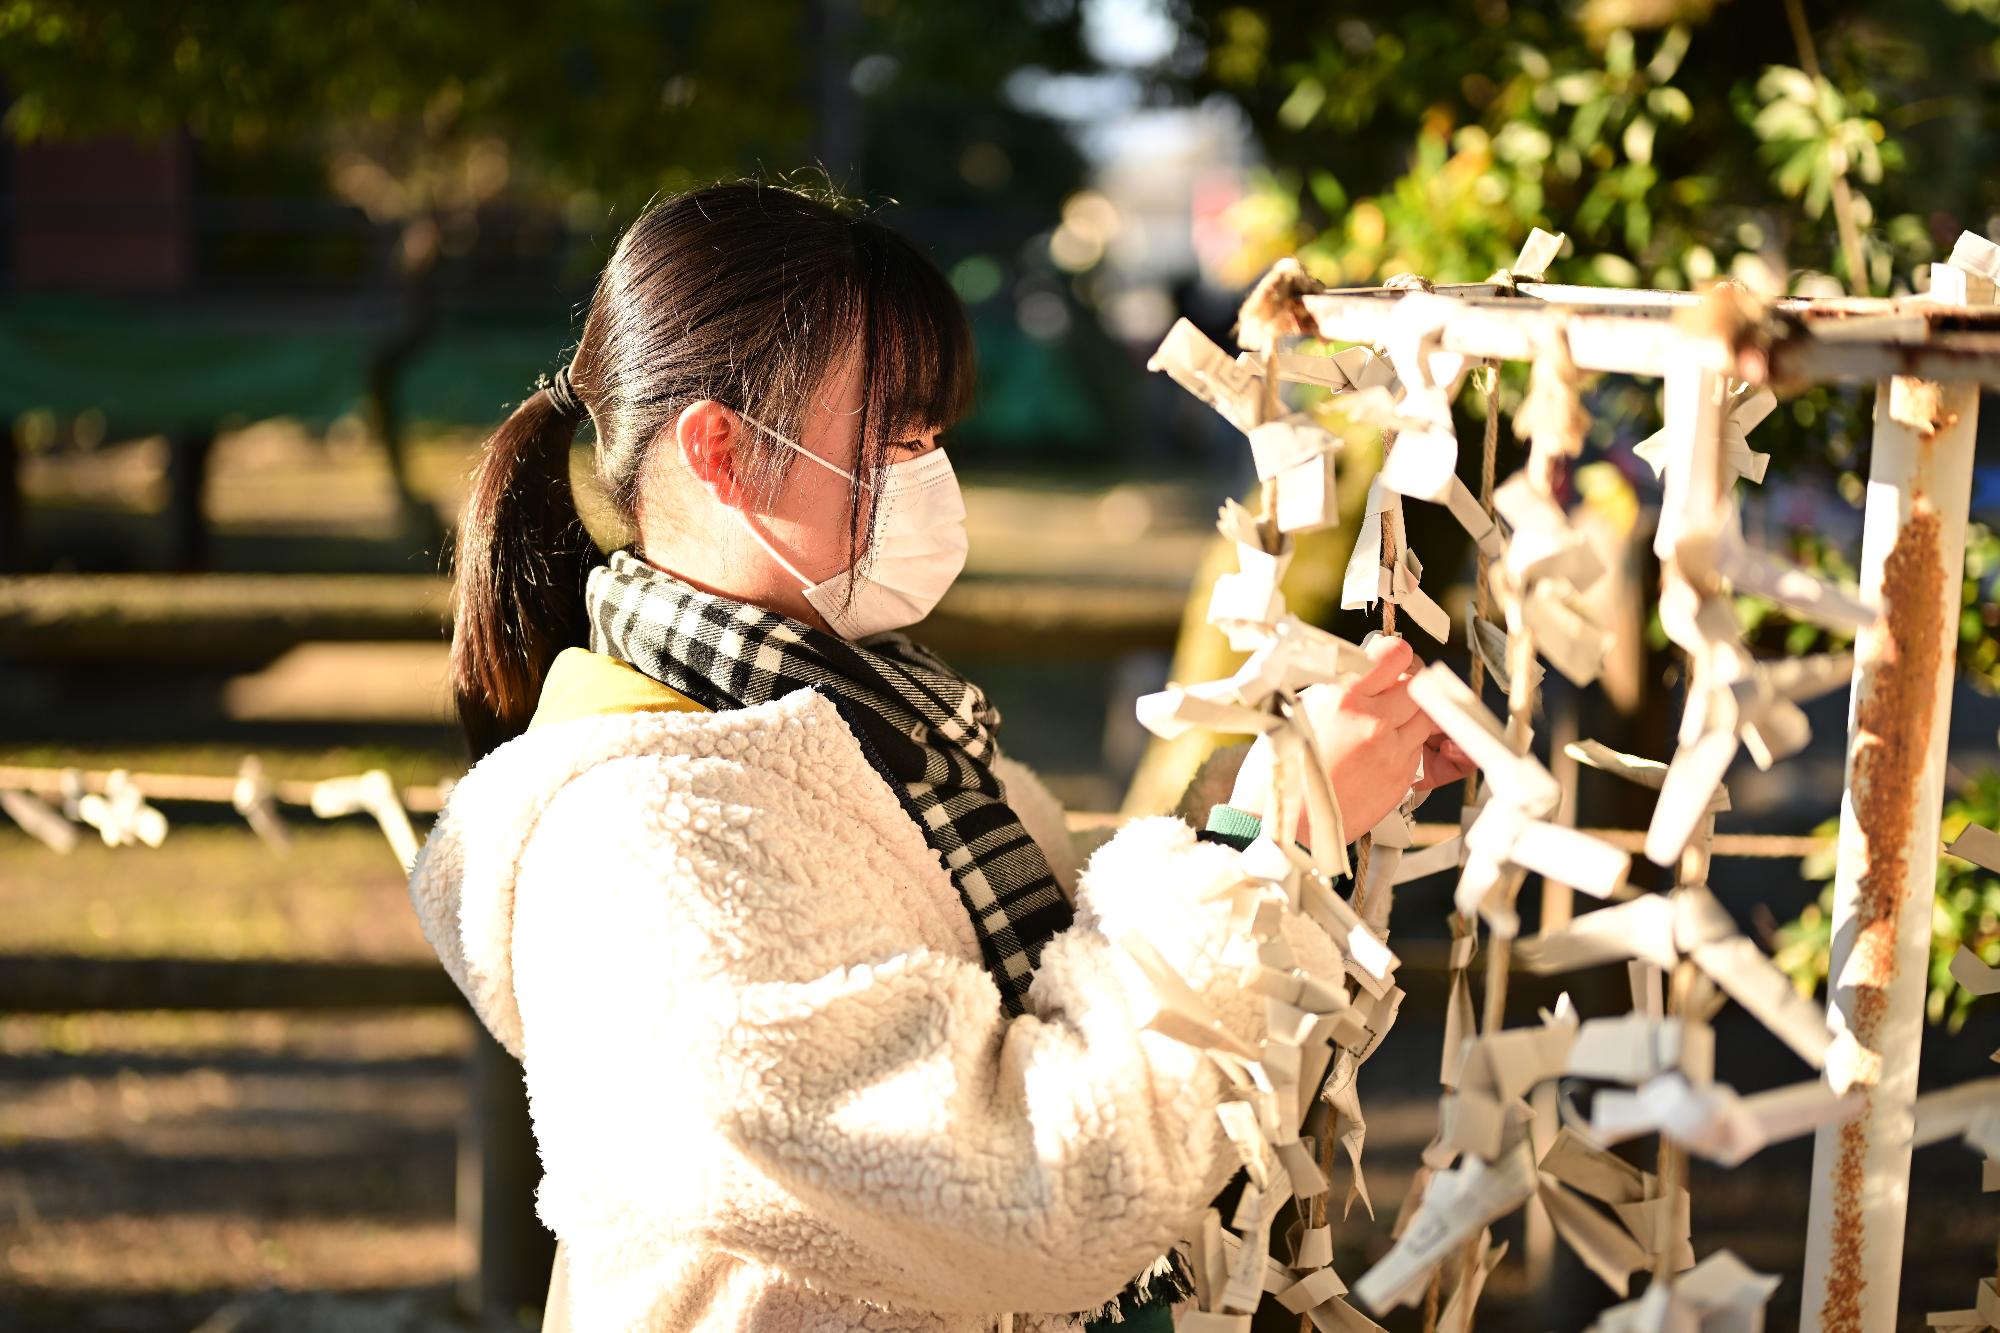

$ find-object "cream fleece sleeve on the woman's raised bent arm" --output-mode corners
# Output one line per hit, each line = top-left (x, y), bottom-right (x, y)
(514, 761), (1336, 1311)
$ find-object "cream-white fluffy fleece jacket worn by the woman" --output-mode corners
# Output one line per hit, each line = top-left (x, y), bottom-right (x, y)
(410, 691), (1336, 1333)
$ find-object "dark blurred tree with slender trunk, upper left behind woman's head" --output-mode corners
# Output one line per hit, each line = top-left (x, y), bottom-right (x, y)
(0, 0), (1102, 466)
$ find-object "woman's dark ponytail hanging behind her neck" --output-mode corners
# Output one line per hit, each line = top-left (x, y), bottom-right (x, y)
(452, 372), (600, 763)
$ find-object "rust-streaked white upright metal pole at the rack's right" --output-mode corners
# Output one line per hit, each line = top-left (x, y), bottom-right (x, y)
(1800, 236), (1992, 1333)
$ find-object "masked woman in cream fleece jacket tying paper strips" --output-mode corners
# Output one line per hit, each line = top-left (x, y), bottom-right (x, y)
(410, 184), (1472, 1333)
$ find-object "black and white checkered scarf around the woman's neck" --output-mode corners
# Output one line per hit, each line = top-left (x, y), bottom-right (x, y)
(584, 548), (1194, 1321)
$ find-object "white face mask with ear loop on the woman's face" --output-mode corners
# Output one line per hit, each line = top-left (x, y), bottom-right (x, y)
(732, 412), (968, 638)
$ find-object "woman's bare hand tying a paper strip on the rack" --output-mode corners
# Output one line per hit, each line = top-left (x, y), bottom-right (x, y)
(1230, 634), (1464, 837)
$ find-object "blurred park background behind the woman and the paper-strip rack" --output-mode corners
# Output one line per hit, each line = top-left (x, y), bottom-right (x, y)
(0, 0), (2000, 1331)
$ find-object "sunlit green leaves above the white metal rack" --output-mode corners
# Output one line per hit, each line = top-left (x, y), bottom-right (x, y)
(1178, 0), (2000, 292)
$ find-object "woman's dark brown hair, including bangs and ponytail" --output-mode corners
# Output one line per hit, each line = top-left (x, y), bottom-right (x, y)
(452, 182), (974, 761)
